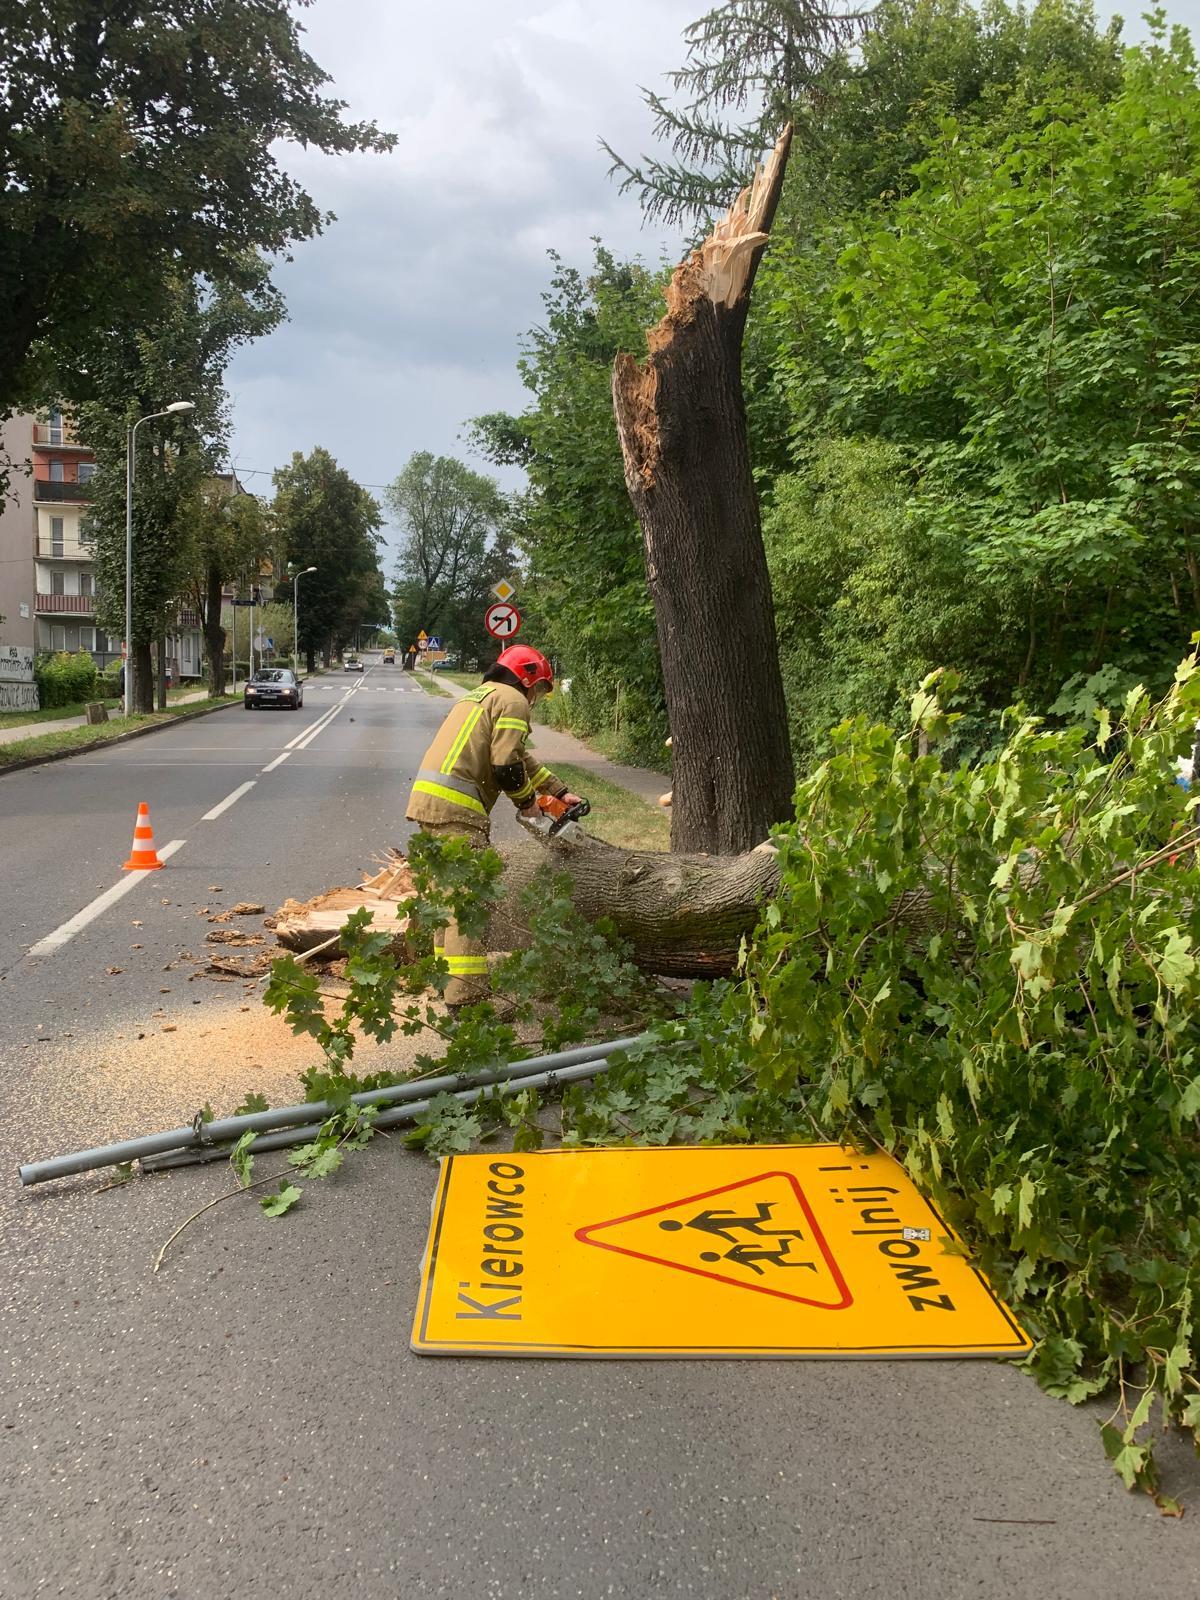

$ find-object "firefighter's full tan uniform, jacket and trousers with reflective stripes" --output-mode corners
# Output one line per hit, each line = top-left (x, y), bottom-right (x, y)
(405, 683), (566, 1005)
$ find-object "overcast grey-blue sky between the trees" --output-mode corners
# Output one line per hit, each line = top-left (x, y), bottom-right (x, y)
(229, 0), (1200, 576)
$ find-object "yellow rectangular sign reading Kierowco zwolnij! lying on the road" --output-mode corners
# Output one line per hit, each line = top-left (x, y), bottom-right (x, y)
(413, 1144), (1030, 1357)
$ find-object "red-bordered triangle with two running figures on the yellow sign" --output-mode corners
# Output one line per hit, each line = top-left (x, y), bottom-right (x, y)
(574, 1171), (853, 1310)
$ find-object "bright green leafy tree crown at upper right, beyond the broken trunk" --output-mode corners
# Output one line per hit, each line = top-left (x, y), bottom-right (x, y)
(834, 18), (1200, 716)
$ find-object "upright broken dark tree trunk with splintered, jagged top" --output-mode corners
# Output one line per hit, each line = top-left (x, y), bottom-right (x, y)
(613, 128), (794, 854)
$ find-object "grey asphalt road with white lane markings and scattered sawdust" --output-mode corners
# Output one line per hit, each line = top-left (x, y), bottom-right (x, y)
(0, 658), (1200, 1600)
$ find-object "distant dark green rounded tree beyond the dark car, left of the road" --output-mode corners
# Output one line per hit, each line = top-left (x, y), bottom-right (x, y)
(272, 446), (387, 672)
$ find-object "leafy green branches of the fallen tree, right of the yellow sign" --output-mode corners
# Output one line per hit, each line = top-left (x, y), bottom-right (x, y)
(733, 656), (1200, 1510)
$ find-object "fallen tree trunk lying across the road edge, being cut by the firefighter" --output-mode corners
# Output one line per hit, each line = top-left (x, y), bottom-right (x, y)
(275, 837), (779, 978)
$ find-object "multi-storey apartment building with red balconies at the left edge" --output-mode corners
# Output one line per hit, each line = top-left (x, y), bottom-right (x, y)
(0, 411), (203, 682)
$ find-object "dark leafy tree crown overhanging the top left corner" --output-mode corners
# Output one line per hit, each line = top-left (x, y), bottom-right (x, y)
(0, 0), (394, 408)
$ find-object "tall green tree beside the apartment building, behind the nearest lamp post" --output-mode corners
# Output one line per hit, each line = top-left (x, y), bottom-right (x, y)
(82, 272), (282, 710)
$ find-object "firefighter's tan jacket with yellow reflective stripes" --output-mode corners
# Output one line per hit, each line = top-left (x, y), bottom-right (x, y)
(406, 683), (566, 829)
